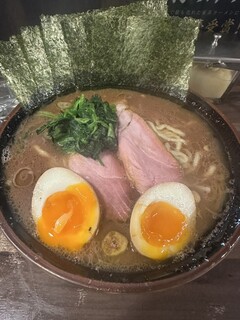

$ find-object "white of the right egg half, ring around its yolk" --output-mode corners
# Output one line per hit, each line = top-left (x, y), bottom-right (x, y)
(130, 182), (196, 260)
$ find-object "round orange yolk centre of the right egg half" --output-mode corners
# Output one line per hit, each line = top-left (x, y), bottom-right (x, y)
(141, 201), (186, 247)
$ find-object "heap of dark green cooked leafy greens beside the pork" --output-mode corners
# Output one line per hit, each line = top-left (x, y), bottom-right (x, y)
(37, 95), (117, 159)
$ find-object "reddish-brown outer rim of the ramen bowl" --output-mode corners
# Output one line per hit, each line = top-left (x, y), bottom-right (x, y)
(0, 93), (240, 293)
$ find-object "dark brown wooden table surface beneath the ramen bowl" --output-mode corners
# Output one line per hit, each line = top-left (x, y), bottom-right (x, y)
(0, 87), (240, 320)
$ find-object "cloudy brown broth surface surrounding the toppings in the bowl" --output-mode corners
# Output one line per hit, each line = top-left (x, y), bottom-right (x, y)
(5, 89), (228, 271)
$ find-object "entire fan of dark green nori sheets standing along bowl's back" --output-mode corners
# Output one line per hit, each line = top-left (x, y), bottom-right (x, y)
(0, 0), (199, 105)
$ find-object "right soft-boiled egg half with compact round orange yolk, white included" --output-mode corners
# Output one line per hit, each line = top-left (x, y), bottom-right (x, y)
(130, 182), (196, 260)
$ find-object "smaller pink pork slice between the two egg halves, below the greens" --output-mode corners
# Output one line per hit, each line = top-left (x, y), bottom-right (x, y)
(68, 151), (133, 221)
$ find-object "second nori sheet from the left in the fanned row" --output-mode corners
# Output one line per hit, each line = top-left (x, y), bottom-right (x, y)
(18, 26), (55, 101)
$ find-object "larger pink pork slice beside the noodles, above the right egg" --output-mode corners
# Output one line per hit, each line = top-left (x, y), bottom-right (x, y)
(117, 104), (182, 193)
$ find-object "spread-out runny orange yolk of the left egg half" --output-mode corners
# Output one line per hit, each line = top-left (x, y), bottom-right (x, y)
(37, 183), (98, 251)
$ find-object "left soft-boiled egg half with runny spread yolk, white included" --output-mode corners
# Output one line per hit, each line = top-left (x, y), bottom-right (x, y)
(32, 168), (100, 251)
